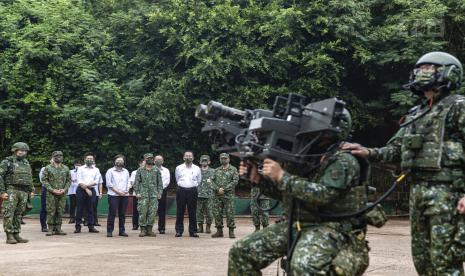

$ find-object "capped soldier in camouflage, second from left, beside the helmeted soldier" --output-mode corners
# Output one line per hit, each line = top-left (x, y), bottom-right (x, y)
(42, 151), (71, 236)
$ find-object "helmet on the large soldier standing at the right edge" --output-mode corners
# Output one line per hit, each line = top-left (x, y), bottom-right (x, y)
(404, 52), (463, 96)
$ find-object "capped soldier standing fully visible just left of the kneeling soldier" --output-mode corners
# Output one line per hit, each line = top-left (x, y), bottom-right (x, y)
(212, 153), (239, 239)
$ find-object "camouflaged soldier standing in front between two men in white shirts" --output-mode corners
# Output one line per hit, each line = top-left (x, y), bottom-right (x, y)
(133, 153), (163, 237)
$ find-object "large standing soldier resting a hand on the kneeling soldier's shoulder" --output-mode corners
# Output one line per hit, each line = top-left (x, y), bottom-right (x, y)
(343, 52), (465, 275)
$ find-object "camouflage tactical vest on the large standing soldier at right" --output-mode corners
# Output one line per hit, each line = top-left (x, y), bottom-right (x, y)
(401, 95), (465, 172)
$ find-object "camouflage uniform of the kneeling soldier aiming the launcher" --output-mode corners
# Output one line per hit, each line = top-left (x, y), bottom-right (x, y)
(228, 151), (368, 275)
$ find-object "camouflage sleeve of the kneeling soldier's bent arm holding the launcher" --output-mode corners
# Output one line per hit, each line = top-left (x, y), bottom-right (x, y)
(277, 154), (360, 206)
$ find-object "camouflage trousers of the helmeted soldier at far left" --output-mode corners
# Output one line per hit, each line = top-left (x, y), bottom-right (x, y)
(3, 189), (28, 233)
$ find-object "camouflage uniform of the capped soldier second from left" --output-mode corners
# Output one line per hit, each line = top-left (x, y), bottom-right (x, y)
(42, 164), (71, 231)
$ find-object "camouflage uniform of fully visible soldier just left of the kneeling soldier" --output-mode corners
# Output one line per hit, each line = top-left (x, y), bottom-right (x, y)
(212, 165), (239, 229)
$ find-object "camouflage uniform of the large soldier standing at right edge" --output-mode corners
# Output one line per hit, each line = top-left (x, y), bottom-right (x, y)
(369, 95), (465, 275)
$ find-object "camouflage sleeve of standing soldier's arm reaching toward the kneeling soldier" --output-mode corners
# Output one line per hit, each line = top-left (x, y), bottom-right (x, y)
(368, 128), (405, 163)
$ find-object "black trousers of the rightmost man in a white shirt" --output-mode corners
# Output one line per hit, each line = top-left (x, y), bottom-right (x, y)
(175, 186), (198, 234)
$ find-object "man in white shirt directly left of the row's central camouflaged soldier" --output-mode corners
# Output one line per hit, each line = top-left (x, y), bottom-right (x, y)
(105, 154), (129, 237)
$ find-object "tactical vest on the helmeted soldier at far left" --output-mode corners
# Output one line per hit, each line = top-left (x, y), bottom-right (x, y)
(5, 157), (32, 187)
